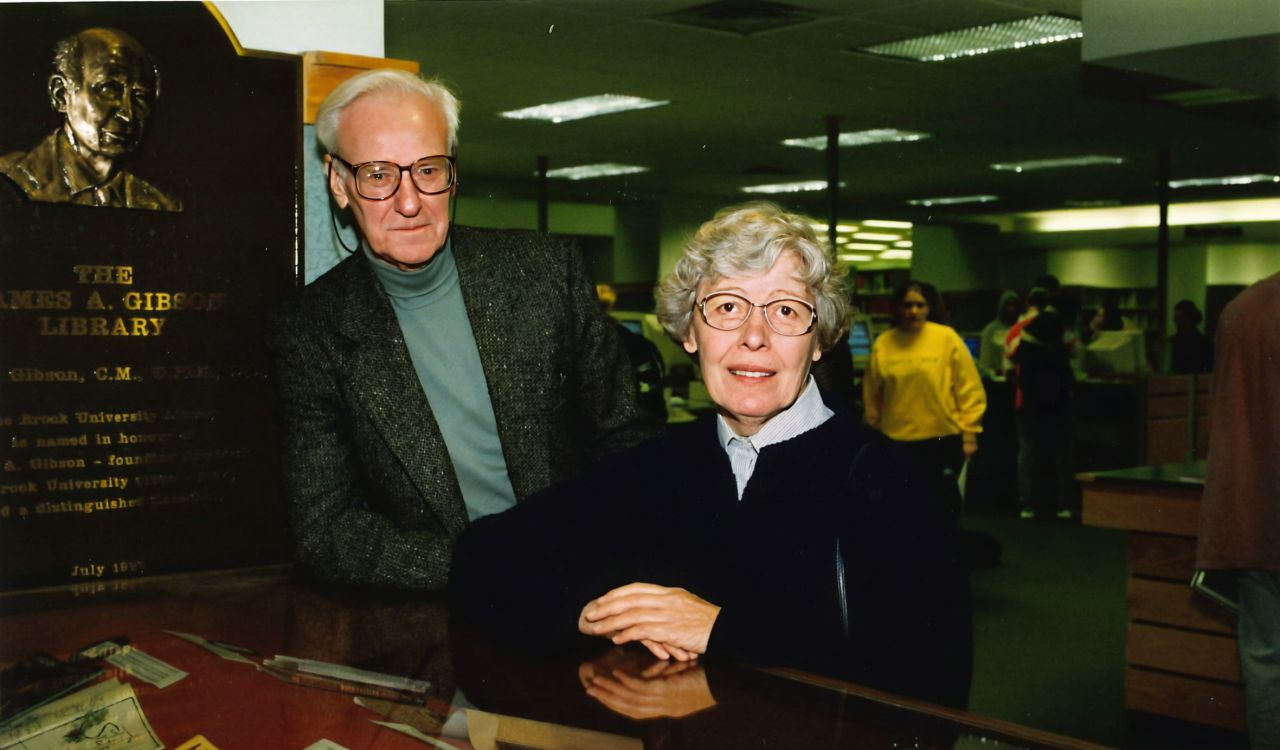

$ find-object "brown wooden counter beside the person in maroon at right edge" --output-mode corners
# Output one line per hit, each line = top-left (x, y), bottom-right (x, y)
(1078, 461), (1244, 732)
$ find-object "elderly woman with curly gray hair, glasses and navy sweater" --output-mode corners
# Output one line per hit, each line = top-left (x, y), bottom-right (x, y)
(451, 203), (972, 705)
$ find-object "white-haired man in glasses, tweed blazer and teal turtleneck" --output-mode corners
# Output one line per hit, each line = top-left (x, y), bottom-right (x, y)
(269, 70), (657, 590)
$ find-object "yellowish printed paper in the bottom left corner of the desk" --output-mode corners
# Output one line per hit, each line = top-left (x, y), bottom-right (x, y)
(0, 680), (164, 750)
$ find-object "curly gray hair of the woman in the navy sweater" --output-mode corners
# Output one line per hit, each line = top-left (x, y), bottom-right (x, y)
(654, 201), (850, 351)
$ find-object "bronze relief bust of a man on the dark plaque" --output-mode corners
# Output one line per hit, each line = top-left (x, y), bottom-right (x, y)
(0, 28), (182, 211)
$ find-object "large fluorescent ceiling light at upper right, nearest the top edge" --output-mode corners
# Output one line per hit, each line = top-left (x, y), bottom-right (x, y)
(854, 15), (1084, 63)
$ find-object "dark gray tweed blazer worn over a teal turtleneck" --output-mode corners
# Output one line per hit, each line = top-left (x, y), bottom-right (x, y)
(268, 227), (658, 590)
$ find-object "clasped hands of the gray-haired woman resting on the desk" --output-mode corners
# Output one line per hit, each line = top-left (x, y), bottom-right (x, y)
(577, 584), (721, 662)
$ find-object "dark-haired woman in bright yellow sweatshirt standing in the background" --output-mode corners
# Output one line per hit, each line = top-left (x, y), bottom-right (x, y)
(863, 282), (987, 513)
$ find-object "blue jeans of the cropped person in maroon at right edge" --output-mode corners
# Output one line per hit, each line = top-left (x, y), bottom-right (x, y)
(1238, 571), (1280, 750)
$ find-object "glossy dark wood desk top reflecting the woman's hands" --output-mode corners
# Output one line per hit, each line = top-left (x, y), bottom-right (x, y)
(0, 568), (1096, 750)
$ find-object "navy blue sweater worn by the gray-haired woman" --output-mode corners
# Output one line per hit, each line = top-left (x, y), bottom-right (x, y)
(451, 416), (973, 708)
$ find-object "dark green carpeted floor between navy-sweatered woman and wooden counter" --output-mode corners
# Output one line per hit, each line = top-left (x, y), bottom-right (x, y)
(961, 513), (1128, 747)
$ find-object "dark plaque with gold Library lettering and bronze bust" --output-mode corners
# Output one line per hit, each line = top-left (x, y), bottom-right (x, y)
(0, 3), (301, 590)
